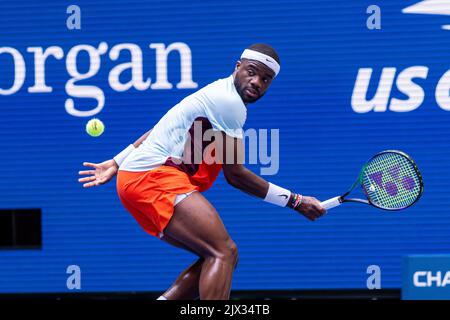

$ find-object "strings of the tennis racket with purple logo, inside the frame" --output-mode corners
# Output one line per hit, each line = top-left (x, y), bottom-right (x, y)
(361, 152), (422, 209)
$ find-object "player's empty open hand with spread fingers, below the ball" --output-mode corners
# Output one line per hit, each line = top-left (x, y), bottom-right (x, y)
(78, 159), (119, 188)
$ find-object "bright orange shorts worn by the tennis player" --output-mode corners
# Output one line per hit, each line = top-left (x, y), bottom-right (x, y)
(117, 166), (199, 238)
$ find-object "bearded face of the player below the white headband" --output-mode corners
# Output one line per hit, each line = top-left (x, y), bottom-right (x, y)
(233, 59), (275, 104)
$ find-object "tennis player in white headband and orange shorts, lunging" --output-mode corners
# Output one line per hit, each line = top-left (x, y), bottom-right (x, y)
(79, 44), (325, 300)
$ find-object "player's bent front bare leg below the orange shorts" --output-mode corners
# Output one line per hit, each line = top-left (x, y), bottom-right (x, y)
(164, 192), (237, 300)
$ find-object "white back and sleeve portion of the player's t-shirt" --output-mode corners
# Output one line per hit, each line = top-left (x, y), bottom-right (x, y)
(119, 75), (247, 171)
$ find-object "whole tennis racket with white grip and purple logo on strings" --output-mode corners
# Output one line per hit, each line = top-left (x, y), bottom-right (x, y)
(321, 150), (423, 211)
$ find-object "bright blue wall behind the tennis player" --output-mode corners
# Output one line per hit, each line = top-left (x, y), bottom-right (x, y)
(0, 0), (450, 292)
